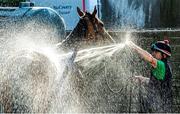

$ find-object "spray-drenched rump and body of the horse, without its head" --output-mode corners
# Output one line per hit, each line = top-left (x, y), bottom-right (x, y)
(0, 47), (83, 113)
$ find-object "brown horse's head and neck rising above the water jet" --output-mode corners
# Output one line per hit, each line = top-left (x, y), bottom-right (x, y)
(58, 7), (115, 49)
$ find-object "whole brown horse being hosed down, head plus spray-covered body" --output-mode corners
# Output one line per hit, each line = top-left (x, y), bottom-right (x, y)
(0, 7), (115, 112)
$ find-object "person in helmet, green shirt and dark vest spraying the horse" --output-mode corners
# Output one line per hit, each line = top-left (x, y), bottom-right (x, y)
(129, 40), (172, 112)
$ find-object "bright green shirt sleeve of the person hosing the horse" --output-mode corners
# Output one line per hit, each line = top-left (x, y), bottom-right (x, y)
(152, 60), (165, 80)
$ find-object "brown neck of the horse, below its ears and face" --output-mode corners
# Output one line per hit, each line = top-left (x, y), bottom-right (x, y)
(62, 22), (115, 49)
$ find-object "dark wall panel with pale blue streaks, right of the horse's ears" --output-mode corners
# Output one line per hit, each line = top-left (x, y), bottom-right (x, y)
(101, 0), (180, 29)
